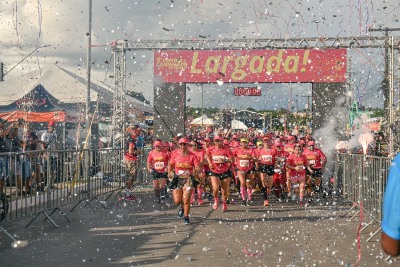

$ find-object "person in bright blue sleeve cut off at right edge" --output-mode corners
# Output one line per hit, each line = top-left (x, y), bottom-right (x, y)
(381, 154), (400, 256)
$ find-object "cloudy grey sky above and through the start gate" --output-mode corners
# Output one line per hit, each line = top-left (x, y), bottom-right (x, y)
(0, 0), (400, 109)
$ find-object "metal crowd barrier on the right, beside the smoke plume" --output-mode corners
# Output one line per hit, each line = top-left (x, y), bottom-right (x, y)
(335, 153), (391, 242)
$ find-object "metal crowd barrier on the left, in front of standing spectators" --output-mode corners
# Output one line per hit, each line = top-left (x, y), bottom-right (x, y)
(0, 149), (147, 238)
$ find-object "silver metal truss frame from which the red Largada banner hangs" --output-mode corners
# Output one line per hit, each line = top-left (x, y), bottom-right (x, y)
(113, 36), (400, 153)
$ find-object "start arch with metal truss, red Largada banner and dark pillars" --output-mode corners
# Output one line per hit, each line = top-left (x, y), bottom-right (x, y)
(112, 36), (400, 156)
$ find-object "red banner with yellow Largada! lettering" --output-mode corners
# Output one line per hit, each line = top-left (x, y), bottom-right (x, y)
(154, 49), (347, 82)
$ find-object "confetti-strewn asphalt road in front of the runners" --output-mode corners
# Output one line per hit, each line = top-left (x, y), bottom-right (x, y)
(0, 188), (399, 267)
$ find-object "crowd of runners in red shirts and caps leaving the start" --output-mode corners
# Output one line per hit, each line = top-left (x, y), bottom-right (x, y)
(125, 128), (327, 224)
